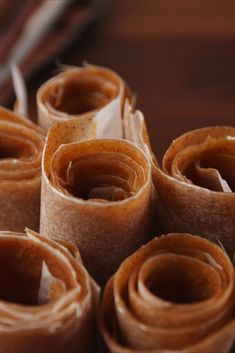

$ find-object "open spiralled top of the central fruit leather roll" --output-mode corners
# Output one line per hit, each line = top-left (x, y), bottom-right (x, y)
(51, 140), (149, 201)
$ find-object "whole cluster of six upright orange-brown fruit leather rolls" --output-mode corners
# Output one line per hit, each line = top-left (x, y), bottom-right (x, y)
(0, 65), (235, 353)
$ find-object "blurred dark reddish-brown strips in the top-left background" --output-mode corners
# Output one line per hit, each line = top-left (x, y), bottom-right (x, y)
(0, 0), (103, 104)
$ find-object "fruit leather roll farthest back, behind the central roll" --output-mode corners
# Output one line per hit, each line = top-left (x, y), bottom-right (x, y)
(37, 65), (130, 130)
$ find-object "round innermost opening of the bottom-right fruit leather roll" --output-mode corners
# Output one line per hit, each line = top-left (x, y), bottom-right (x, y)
(140, 254), (222, 304)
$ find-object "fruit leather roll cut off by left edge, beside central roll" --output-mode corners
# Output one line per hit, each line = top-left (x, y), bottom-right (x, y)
(0, 107), (44, 231)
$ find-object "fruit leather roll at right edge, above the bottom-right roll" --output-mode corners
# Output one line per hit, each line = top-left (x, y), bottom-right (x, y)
(154, 126), (235, 255)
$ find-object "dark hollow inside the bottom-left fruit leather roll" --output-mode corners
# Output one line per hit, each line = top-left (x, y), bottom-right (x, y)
(0, 238), (72, 306)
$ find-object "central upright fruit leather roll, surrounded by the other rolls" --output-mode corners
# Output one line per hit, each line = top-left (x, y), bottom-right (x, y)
(40, 97), (152, 284)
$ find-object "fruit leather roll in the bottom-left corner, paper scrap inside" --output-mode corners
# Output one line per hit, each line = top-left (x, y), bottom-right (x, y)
(0, 230), (98, 353)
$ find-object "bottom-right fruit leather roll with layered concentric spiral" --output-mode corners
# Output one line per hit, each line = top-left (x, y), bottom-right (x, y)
(100, 233), (235, 353)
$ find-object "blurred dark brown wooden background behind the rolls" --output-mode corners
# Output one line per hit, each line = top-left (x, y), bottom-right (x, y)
(0, 0), (235, 159)
